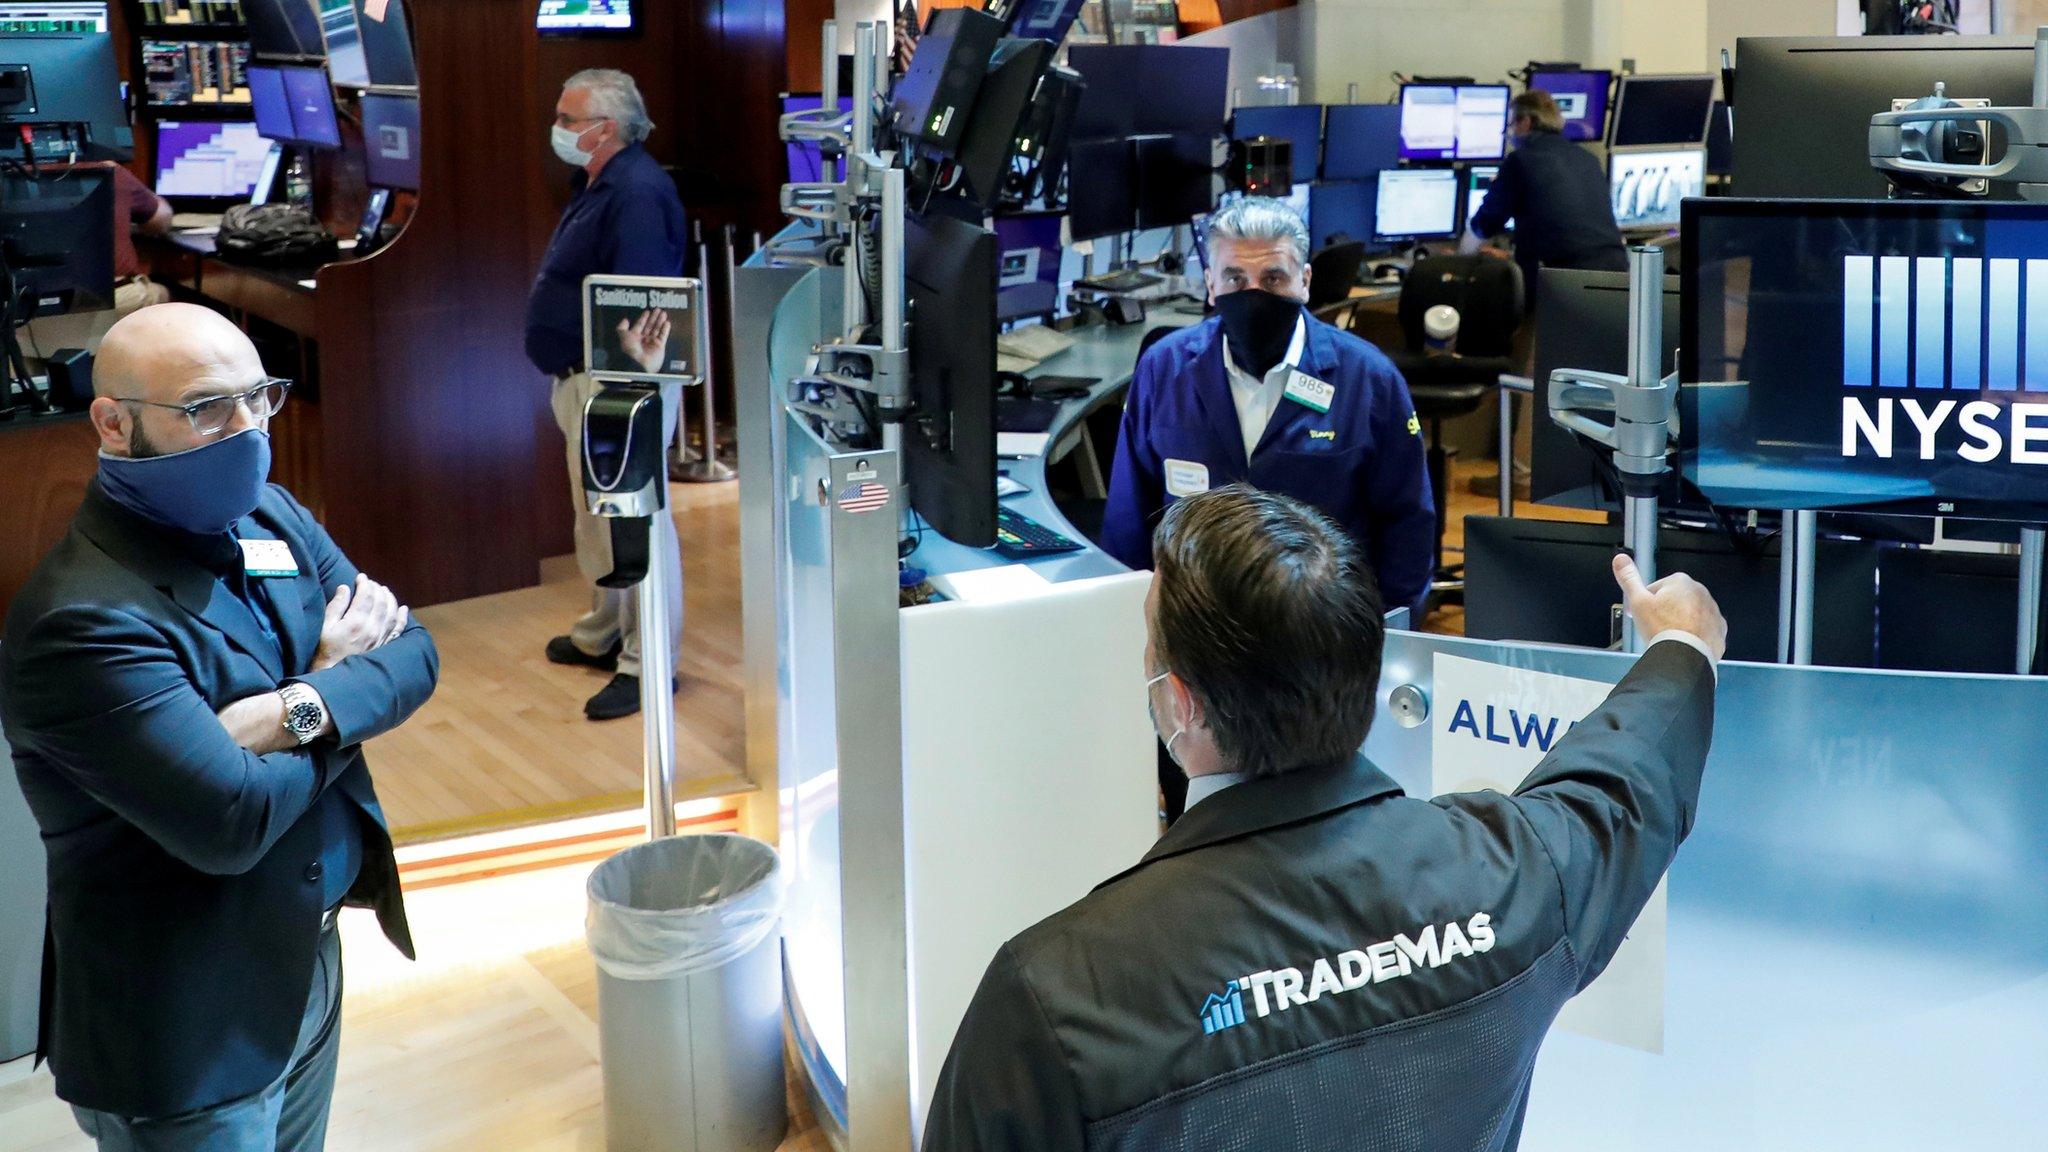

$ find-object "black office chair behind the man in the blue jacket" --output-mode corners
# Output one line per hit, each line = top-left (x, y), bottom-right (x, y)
(1386, 256), (1522, 615)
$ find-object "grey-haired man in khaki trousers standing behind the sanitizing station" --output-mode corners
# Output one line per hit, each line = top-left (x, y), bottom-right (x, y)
(526, 68), (688, 719)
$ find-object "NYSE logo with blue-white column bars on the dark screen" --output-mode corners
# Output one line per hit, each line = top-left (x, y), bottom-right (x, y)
(1841, 256), (2048, 465)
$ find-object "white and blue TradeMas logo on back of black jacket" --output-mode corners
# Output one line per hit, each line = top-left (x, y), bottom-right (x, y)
(1200, 912), (1493, 1035)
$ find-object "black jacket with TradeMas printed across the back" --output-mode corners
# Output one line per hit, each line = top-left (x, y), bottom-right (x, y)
(924, 642), (1714, 1152)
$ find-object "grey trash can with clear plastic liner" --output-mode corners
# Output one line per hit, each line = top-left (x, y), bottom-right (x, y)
(584, 834), (788, 1152)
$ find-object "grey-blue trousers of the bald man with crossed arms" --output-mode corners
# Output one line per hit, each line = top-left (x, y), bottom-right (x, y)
(72, 914), (342, 1152)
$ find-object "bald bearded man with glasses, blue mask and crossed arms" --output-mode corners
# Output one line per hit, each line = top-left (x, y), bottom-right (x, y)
(0, 303), (438, 1152)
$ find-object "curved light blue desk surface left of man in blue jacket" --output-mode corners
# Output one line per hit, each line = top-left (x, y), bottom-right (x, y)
(909, 305), (1202, 584)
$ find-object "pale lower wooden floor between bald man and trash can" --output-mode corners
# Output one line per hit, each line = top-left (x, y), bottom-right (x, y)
(0, 865), (827, 1152)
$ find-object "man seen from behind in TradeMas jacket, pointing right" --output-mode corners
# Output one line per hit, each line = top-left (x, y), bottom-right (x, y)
(924, 486), (1726, 1152)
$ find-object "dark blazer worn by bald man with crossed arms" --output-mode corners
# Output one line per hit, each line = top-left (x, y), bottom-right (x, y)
(0, 482), (440, 1117)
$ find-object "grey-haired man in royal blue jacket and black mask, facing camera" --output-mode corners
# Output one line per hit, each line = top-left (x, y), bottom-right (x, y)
(1102, 197), (1436, 824)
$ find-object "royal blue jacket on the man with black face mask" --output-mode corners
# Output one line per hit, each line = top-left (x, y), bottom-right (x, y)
(1102, 316), (1436, 609)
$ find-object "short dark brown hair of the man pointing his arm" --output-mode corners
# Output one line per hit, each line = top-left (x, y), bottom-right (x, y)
(1151, 484), (1386, 777)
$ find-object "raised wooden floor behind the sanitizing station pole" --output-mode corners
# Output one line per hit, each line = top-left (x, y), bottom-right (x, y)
(369, 484), (745, 842)
